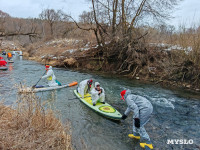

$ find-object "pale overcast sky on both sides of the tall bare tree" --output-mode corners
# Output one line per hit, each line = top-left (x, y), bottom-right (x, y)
(0, 0), (200, 26)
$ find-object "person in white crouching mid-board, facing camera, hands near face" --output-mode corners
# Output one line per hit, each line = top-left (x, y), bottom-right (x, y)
(91, 82), (105, 106)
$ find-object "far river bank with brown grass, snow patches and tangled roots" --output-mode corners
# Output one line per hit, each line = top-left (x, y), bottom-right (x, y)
(21, 39), (200, 92)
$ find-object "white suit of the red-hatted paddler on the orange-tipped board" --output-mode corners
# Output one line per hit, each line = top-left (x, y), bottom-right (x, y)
(42, 66), (58, 86)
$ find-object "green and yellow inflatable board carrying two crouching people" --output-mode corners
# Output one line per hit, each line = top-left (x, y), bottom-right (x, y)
(74, 90), (122, 120)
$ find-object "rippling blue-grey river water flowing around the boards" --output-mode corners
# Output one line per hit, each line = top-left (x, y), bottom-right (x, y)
(0, 57), (200, 150)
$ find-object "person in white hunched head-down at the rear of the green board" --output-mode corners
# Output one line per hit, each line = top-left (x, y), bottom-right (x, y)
(78, 79), (94, 98)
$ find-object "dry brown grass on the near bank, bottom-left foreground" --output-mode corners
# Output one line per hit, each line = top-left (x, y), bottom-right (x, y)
(0, 85), (72, 150)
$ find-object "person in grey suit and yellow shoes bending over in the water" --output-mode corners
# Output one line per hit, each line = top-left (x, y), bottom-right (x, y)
(121, 90), (153, 149)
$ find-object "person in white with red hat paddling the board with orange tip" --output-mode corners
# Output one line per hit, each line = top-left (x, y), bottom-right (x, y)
(42, 65), (61, 86)
